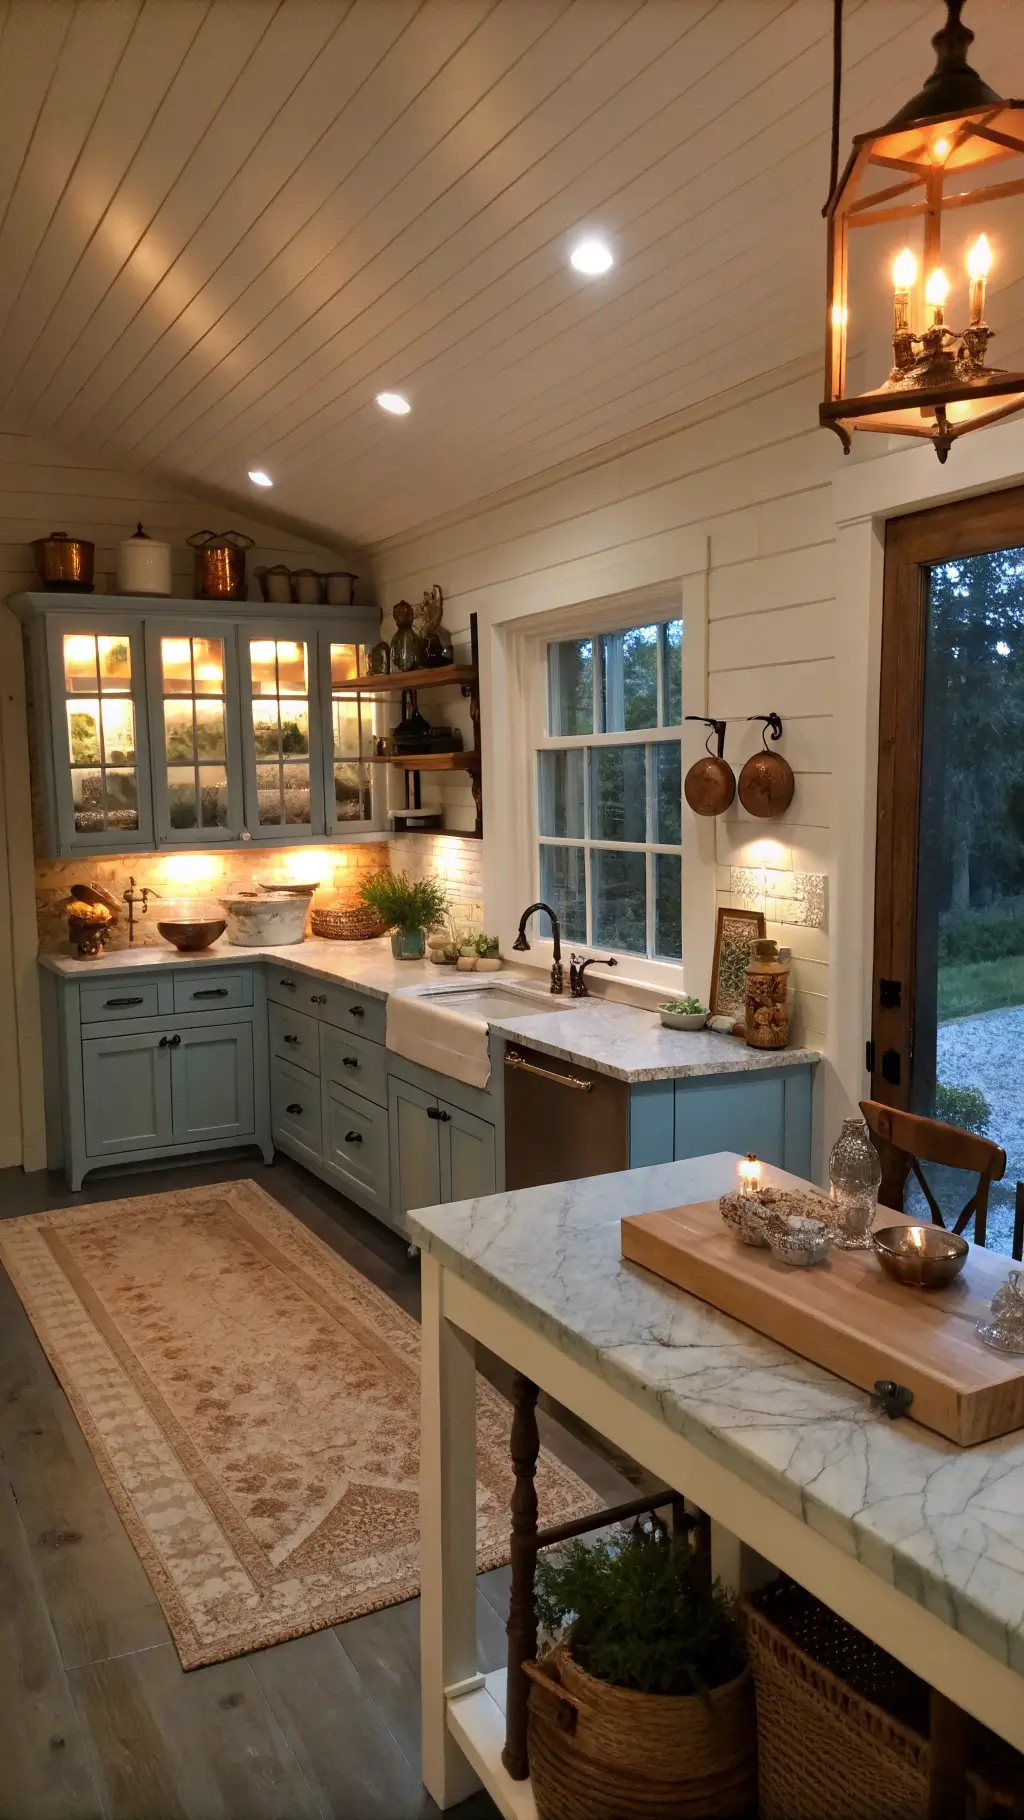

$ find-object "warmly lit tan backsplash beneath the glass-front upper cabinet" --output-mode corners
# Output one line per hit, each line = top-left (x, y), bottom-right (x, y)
(36, 841), (387, 954)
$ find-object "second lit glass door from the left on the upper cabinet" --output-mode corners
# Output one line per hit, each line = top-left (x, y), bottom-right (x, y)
(146, 624), (242, 846)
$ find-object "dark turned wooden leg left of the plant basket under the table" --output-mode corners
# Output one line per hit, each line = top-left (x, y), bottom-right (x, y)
(502, 1372), (540, 1782)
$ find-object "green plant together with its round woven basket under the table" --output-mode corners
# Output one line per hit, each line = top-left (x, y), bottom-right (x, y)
(526, 1523), (757, 1820)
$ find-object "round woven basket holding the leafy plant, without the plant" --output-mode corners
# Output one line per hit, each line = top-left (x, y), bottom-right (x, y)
(526, 1645), (757, 1820)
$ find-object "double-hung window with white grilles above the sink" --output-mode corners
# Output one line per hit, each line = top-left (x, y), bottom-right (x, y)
(537, 617), (682, 965)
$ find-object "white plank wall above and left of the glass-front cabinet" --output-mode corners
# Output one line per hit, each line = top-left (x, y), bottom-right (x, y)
(0, 433), (369, 1168)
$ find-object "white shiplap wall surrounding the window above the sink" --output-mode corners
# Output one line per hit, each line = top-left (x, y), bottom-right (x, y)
(375, 369), (840, 1043)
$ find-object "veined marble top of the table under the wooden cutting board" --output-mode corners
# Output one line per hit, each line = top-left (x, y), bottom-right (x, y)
(407, 1152), (1024, 1673)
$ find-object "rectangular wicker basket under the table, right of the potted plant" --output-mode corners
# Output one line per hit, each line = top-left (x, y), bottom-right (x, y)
(740, 1578), (1020, 1820)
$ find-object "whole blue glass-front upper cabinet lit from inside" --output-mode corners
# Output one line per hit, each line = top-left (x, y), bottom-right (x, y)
(13, 593), (382, 857)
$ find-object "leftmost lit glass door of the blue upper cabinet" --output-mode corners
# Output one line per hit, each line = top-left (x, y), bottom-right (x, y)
(49, 619), (153, 854)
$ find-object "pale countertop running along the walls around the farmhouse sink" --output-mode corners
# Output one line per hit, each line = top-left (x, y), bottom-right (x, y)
(40, 935), (820, 1083)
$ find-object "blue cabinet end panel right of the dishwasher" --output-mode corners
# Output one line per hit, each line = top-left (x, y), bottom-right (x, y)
(629, 1067), (811, 1178)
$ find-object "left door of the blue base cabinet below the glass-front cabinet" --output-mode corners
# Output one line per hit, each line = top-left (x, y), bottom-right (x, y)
(82, 1032), (175, 1159)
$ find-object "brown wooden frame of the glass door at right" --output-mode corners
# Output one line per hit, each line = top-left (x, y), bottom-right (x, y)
(871, 486), (1024, 1110)
